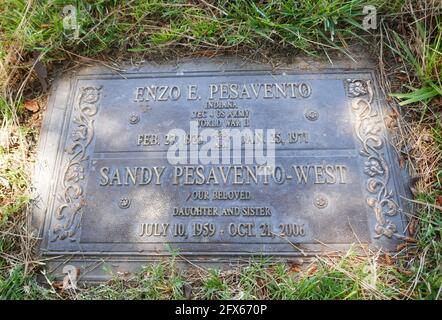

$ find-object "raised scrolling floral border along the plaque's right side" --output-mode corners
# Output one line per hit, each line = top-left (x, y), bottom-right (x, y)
(346, 79), (400, 239)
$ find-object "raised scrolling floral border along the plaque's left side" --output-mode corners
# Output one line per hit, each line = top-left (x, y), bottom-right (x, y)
(50, 86), (102, 242)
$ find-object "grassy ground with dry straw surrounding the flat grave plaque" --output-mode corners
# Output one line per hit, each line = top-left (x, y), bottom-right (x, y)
(0, 0), (442, 299)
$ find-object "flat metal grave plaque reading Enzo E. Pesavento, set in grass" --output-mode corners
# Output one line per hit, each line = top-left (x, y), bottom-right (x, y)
(33, 62), (407, 280)
